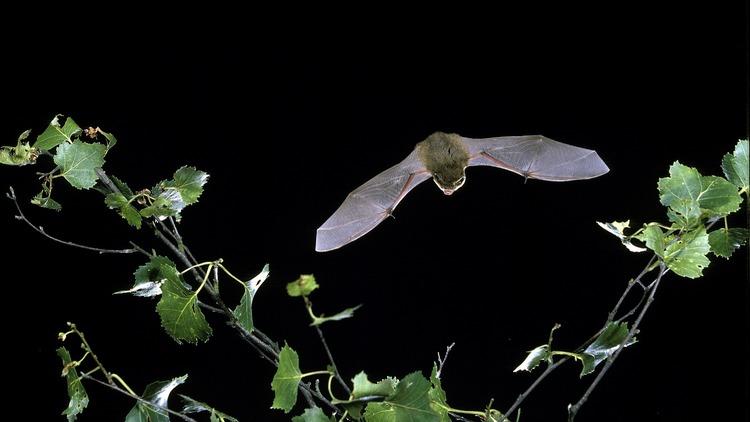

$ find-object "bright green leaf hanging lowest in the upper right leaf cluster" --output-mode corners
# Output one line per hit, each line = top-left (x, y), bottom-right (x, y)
(664, 226), (711, 278)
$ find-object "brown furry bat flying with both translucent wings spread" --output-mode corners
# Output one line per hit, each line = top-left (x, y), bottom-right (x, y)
(315, 132), (609, 252)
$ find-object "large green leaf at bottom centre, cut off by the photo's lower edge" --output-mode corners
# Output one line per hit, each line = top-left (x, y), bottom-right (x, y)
(365, 372), (441, 422)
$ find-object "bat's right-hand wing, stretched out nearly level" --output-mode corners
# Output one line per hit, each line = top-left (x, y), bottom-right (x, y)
(461, 135), (609, 182)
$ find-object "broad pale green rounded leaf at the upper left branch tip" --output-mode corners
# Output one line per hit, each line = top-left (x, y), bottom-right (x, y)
(54, 141), (105, 189)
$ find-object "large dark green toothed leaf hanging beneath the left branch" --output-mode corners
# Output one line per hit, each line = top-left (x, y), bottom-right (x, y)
(156, 265), (211, 344)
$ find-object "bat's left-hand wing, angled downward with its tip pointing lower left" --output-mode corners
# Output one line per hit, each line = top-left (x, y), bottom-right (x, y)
(315, 150), (431, 252)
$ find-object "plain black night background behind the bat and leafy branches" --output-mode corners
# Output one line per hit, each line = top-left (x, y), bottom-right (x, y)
(0, 2), (748, 421)
